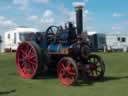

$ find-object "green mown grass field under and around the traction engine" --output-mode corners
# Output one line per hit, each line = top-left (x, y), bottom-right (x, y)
(0, 53), (128, 96)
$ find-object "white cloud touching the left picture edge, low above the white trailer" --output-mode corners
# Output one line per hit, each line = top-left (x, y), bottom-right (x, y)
(0, 16), (17, 29)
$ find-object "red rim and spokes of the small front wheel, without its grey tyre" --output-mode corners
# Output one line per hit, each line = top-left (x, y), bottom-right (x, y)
(57, 60), (76, 86)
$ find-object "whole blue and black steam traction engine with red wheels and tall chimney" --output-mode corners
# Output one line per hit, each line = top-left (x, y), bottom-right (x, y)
(16, 5), (105, 85)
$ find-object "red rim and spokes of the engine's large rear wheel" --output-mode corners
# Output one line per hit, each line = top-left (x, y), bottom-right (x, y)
(16, 42), (38, 79)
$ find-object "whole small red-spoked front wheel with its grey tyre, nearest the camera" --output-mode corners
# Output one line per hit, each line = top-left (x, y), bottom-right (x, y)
(57, 57), (78, 86)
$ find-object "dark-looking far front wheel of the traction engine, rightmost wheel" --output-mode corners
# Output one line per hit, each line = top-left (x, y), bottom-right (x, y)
(84, 55), (105, 79)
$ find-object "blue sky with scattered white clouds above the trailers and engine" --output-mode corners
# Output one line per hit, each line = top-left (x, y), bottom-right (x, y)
(0, 0), (128, 34)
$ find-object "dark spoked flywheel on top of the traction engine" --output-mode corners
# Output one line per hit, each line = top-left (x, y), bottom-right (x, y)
(46, 25), (59, 42)
